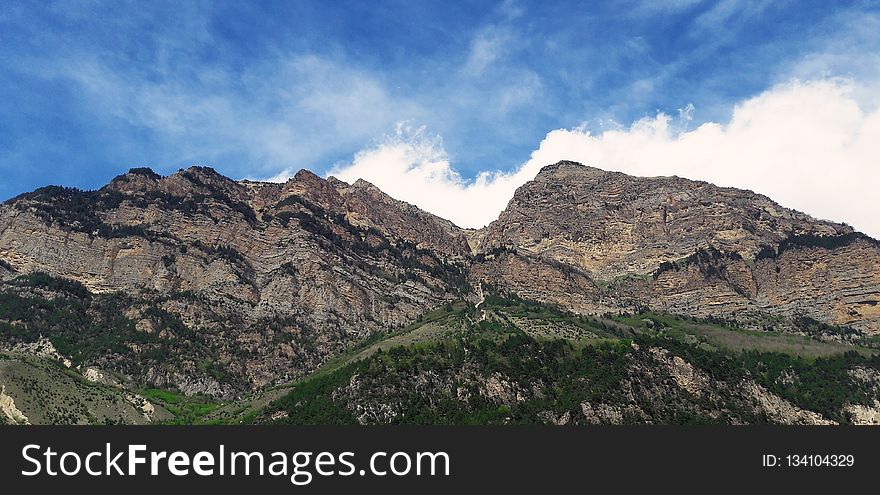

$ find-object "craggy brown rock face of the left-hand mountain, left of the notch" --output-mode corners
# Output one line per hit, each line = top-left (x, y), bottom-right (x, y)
(0, 167), (469, 396)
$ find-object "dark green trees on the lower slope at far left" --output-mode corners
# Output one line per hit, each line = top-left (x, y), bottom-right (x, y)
(0, 273), (244, 394)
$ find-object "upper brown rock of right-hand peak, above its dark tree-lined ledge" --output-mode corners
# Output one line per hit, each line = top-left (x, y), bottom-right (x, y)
(483, 161), (853, 270)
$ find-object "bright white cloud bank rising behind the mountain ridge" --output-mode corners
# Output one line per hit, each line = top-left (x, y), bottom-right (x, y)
(331, 79), (880, 237)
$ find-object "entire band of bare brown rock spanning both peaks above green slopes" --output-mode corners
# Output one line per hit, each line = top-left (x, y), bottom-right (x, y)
(0, 162), (880, 397)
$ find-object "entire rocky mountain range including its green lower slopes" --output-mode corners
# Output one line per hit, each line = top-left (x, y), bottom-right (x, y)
(0, 162), (880, 423)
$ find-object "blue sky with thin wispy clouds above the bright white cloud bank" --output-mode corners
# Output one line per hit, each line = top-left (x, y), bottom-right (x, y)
(0, 0), (880, 232)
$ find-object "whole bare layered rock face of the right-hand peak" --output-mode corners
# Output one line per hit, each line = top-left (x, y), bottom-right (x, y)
(473, 162), (880, 334)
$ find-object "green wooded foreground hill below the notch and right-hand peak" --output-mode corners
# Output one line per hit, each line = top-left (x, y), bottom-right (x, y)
(260, 294), (880, 424)
